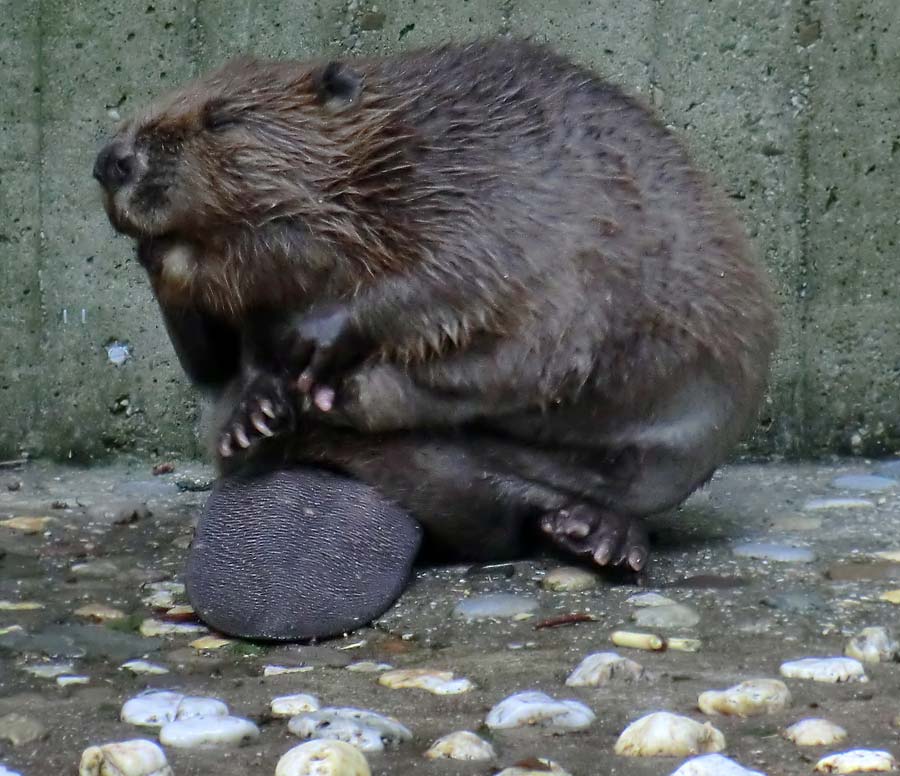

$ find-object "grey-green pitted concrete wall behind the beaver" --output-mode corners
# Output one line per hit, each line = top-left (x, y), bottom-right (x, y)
(0, 0), (900, 460)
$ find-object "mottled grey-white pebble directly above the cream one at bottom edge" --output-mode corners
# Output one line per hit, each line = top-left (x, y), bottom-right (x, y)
(288, 708), (412, 752)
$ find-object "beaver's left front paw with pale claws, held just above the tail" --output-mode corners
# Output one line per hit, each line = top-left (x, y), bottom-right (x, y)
(218, 375), (295, 458)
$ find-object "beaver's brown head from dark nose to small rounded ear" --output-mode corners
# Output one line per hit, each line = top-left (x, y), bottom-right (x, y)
(94, 59), (380, 237)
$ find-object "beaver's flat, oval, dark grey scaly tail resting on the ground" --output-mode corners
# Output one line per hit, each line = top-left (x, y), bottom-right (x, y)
(186, 468), (422, 641)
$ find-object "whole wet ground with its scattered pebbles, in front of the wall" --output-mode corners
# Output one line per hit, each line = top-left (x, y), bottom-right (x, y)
(0, 460), (900, 776)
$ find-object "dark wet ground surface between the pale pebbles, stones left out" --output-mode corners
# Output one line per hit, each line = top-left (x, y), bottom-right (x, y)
(0, 462), (900, 776)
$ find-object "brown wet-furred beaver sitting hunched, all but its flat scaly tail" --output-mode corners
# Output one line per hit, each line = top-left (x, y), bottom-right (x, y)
(95, 39), (776, 570)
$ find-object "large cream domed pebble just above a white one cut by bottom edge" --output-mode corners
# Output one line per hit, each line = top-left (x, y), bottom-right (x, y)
(615, 711), (725, 757)
